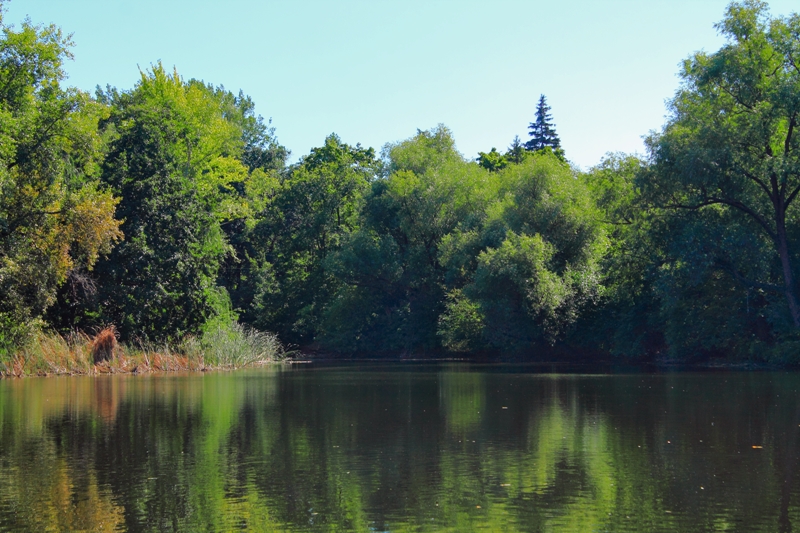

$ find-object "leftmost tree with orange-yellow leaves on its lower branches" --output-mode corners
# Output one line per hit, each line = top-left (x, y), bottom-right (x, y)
(0, 7), (122, 354)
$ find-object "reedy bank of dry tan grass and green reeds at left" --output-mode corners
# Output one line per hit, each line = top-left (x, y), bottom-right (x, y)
(0, 324), (288, 377)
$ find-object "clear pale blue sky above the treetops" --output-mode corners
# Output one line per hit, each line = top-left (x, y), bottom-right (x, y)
(5, 0), (800, 168)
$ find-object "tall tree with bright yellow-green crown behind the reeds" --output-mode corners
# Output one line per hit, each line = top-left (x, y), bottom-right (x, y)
(87, 64), (249, 341)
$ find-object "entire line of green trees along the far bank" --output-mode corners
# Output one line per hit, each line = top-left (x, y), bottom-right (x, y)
(0, 0), (800, 363)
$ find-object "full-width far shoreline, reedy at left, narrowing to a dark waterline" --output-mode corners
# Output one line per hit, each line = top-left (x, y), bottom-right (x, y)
(0, 332), (798, 379)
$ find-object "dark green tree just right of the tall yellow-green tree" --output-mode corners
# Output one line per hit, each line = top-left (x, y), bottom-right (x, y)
(244, 131), (377, 343)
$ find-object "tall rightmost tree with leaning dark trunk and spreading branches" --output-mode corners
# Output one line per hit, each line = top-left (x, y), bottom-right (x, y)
(638, 0), (800, 328)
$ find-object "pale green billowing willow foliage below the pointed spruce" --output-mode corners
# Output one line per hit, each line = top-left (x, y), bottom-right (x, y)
(439, 154), (606, 351)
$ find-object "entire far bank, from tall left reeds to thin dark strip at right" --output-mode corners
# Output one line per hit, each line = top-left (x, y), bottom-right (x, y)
(0, 330), (780, 378)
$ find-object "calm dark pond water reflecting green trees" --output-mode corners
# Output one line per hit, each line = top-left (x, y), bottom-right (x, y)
(0, 364), (800, 532)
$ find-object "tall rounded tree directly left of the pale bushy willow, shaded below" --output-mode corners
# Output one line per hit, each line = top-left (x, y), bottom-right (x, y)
(321, 125), (496, 352)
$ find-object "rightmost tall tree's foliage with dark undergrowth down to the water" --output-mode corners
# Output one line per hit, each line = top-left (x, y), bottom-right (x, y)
(636, 1), (800, 357)
